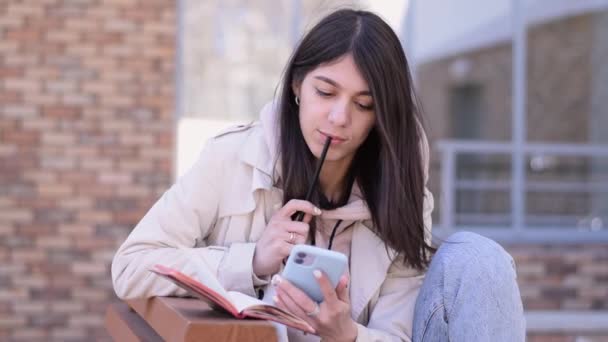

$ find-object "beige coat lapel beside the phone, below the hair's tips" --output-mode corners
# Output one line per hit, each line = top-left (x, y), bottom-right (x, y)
(350, 223), (394, 320)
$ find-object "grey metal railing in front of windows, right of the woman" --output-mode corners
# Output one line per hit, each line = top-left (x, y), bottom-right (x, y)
(436, 140), (608, 241)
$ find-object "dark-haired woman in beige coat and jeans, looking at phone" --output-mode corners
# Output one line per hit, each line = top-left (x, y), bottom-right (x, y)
(112, 10), (523, 341)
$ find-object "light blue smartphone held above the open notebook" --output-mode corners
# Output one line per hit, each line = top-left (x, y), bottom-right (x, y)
(281, 245), (348, 303)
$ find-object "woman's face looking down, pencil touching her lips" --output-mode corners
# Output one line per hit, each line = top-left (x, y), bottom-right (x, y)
(293, 54), (376, 163)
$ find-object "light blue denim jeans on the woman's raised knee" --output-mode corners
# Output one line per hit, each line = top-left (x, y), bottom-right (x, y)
(413, 232), (526, 342)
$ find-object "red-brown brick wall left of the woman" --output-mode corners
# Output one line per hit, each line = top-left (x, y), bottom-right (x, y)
(0, 0), (176, 341)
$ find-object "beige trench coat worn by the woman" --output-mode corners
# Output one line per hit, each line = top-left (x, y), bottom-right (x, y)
(112, 123), (433, 341)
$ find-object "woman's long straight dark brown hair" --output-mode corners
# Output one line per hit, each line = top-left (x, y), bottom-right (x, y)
(278, 9), (435, 269)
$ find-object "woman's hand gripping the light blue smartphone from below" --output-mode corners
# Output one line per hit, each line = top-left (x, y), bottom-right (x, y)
(273, 270), (357, 342)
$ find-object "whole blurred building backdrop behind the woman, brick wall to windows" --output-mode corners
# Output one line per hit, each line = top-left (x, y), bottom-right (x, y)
(0, 0), (608, 342)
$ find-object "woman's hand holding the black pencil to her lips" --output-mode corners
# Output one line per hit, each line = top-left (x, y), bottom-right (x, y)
(253, 199), (321, 277)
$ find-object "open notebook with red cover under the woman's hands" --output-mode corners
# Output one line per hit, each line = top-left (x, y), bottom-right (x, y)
(150, 265), (314, 333)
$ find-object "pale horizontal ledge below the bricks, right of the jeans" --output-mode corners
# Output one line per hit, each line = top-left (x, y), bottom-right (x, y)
(525, 311), (608, 334)
